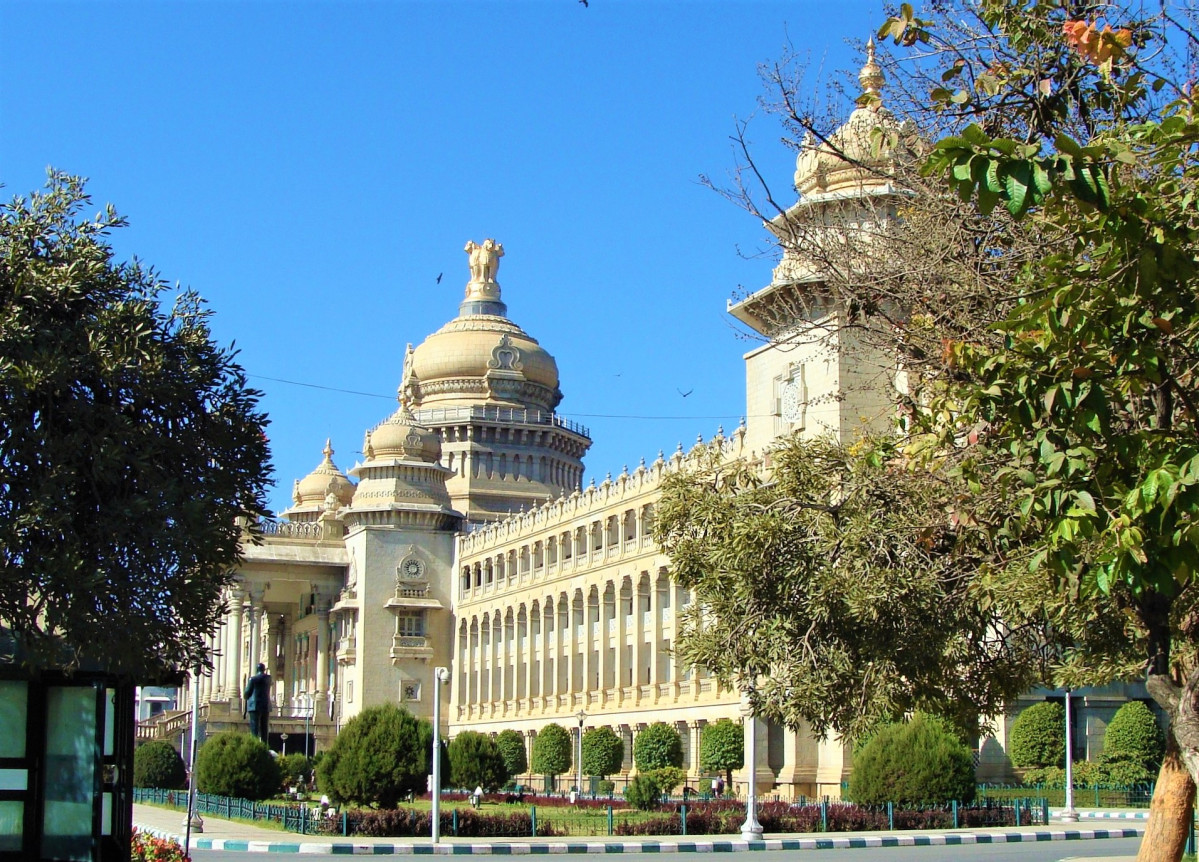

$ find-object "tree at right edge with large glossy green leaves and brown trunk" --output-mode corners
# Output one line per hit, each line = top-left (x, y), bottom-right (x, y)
(884, 0), (1199, 858)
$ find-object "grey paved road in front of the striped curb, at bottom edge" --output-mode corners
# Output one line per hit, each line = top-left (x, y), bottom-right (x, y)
(192, 838), (1140, 862)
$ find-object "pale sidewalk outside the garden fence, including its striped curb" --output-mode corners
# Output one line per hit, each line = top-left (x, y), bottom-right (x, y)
(133, 804), (1145, 862)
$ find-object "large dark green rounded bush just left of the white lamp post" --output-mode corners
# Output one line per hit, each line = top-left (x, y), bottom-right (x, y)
(318, 704), (433, 808)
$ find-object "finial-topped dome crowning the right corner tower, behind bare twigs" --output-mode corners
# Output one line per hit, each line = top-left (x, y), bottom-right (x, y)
(795, 40), (899, 194)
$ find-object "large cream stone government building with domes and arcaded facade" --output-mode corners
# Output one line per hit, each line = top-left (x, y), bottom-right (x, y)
(157, 56), (1141, 796)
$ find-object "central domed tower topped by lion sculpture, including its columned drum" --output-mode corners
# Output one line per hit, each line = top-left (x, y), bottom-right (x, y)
(399, 239), (591, 523)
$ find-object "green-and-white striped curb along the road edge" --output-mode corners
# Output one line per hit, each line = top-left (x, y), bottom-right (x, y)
(138, 826), (1145, 856)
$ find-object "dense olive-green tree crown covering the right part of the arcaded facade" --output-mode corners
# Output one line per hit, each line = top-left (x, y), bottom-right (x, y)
(655, 438), (1044, 737)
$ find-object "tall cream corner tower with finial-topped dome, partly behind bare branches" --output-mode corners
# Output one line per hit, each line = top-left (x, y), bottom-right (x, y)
(728, 40), (918, 452)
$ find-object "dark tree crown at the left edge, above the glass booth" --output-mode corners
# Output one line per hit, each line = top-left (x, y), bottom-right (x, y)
(0, 171), (270, 673)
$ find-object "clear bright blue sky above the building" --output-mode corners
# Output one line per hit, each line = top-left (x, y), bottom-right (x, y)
(0, 0), (884, 510)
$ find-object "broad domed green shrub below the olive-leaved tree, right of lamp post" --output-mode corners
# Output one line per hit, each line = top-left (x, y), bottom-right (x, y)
(849, 712), (975, 807)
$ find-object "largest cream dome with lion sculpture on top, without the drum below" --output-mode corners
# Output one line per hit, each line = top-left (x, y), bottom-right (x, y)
(400, 240), (562, 410)
